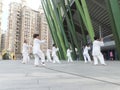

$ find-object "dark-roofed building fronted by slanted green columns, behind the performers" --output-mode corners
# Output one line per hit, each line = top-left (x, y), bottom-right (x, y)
(41, 0), (120, 60)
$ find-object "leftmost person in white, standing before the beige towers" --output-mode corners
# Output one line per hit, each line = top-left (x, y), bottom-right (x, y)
(22, 40), (32, 64)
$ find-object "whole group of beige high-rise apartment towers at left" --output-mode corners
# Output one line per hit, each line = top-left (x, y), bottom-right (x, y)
(5, 0), (52, 54)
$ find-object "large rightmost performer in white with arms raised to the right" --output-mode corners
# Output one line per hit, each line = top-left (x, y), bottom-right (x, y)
(92, 37), (106, 65)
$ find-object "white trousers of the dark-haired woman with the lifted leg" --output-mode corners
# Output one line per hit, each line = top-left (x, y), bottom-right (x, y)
(34, 51), (45, 65)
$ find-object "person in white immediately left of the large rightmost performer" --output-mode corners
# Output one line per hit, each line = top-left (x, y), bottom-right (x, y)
(83, 44), (91, 63)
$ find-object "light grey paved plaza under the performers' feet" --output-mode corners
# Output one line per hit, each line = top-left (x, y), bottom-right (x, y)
(0, 60), (120, 90)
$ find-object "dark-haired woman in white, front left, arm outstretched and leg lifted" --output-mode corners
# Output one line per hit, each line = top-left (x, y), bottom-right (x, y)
(33, 34), (45, 66)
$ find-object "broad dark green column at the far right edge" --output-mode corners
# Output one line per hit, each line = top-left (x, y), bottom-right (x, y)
(105, 0), (120, 60)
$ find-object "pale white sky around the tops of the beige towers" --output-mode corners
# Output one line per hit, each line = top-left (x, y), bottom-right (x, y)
(2, 0), (40, 31)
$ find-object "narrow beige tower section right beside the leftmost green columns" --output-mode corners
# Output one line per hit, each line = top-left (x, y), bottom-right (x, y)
(40, 8), (52, 52)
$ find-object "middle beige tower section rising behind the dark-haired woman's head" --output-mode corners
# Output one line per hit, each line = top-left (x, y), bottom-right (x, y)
(21, 6), (40, 52)
